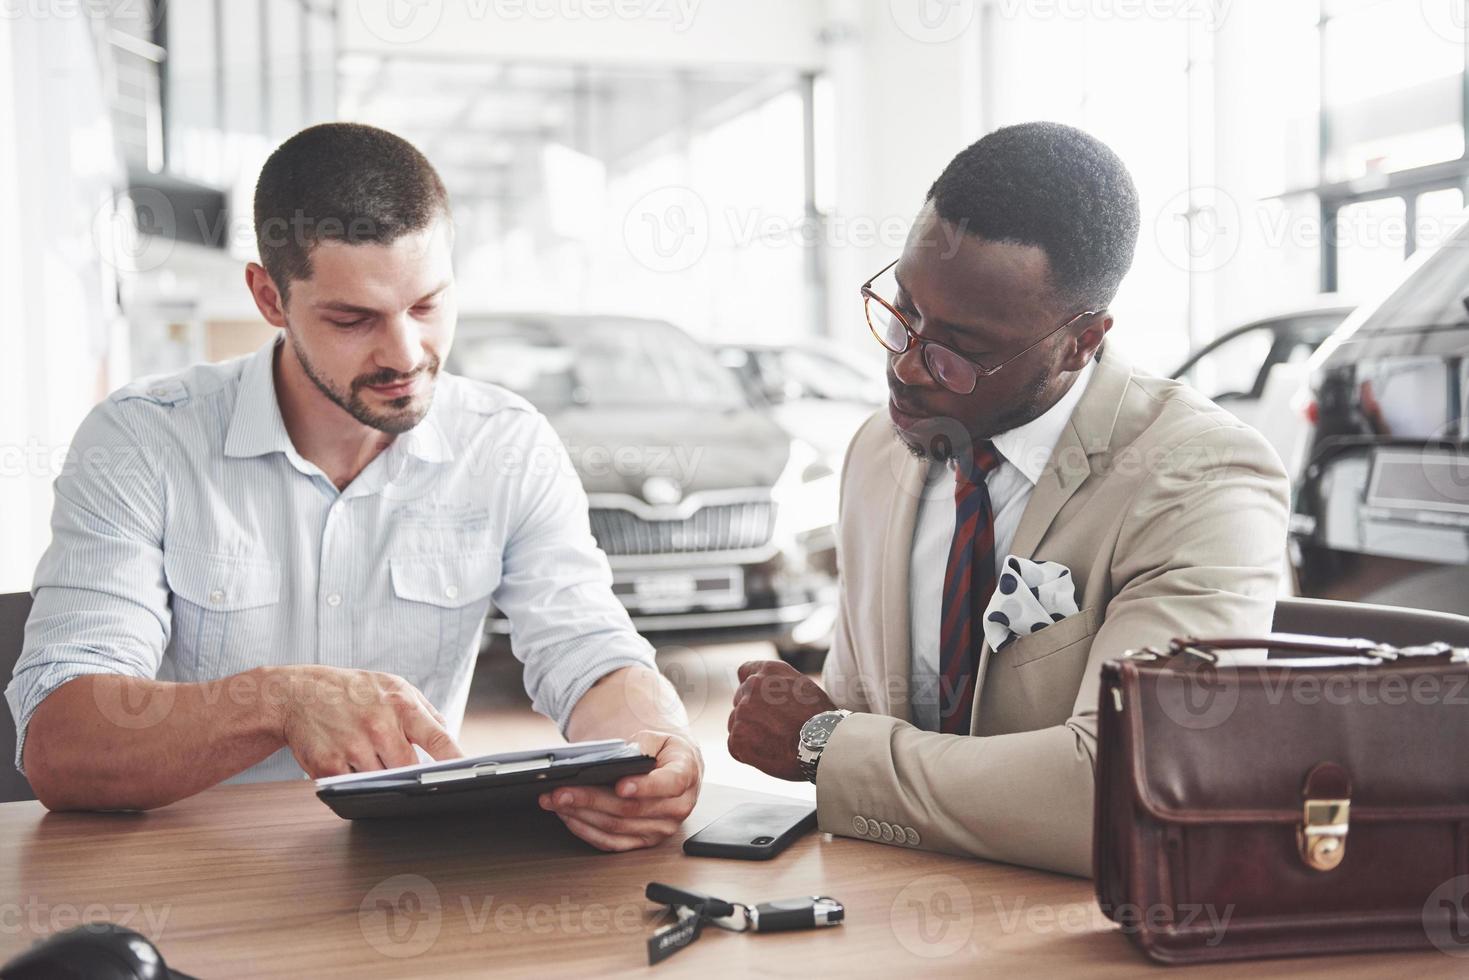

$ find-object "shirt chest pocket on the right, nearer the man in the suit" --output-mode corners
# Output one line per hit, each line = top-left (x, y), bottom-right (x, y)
(388, 551), (499, 673)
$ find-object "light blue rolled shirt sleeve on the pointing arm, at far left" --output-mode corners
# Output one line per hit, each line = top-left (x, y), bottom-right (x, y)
(6, 400), (170, 771)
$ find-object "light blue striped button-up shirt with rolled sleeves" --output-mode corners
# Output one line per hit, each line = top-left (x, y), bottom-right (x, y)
(6, 336), (654, 782)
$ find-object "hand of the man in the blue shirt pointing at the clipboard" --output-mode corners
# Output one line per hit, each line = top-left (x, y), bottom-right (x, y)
(264, 667), (464, 779)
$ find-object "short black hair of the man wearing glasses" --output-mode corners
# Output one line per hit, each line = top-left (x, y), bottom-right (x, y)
(927, 122), (1138, 309)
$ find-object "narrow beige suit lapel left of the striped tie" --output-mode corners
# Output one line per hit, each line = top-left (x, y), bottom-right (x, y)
(878, 439), (928, 721)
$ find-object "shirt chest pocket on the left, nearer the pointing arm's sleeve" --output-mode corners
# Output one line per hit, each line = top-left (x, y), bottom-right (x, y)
(163, 548), (281, 680)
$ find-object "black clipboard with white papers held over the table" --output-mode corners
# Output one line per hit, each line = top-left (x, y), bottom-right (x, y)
(316, 739), (657, 820)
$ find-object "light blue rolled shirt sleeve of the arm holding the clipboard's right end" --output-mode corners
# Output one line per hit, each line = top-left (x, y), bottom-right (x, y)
(494, 414), (655, 735)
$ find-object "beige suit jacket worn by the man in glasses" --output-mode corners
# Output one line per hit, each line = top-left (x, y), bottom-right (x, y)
(817, 350), (1288, 876)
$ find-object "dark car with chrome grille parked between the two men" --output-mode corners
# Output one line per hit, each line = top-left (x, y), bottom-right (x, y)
(448, 314), (837, 664)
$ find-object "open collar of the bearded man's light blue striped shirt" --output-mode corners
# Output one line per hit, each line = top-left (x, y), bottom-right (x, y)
(225, 334), (454, 466)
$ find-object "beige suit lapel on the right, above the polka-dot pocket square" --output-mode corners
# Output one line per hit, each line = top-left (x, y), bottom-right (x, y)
(970, 351), (1133, 735)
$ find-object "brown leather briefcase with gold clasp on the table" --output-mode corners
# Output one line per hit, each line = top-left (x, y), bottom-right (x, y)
(1093, 633), (1469, 974)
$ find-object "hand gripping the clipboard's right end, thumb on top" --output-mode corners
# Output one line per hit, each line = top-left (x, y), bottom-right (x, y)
(541, 730), (704, 851)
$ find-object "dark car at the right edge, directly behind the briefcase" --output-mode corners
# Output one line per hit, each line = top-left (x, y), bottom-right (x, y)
(1291, 226), (1469, 613)
